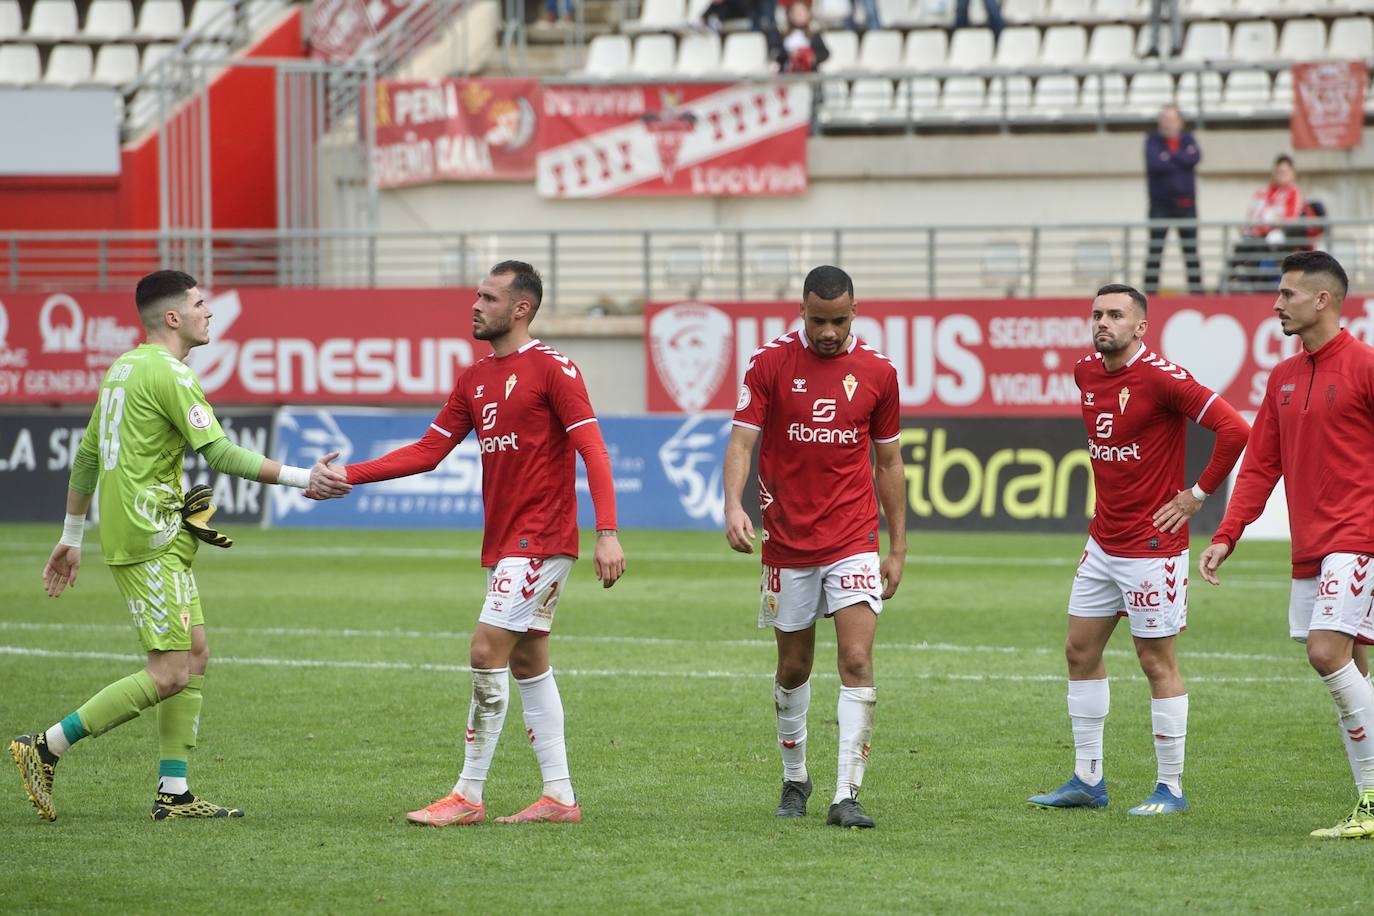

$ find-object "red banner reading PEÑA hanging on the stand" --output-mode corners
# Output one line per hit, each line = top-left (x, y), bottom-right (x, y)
(374, 78), (539, 188)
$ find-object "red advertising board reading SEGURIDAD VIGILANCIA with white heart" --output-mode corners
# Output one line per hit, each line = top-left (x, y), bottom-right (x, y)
(644, 295), (1374, 416)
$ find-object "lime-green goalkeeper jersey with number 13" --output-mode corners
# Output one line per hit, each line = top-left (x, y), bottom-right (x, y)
(78, 343), (224, 566)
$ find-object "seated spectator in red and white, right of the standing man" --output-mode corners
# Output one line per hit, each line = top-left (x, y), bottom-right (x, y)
(1230, 155), (1311, 291)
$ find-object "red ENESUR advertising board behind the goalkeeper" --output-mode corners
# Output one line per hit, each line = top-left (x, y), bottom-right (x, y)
(0, 287), (491, 405)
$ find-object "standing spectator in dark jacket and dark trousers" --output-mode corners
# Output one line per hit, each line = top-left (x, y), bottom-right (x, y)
(1145, 104), (1202, 295)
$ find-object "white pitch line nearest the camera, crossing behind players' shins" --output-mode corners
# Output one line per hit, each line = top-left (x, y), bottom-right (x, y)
(0, 645), (1312, 684)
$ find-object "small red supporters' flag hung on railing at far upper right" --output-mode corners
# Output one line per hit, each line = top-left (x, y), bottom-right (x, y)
(1289, 60), (1369, 150)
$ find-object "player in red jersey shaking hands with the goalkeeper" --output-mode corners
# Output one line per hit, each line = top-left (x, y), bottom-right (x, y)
(348, 261), (625, 827)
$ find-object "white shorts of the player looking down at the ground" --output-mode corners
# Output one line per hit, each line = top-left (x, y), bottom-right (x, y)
(758, 553), (882, 633)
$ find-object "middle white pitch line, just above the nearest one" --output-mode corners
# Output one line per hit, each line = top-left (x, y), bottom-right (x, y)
(0, 621), (1303, 663)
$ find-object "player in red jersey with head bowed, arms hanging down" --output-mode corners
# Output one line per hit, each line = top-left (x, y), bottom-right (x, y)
(724, 266), (907, 827)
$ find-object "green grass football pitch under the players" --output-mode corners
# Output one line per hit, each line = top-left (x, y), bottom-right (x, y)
(0, 525), (1374, 913)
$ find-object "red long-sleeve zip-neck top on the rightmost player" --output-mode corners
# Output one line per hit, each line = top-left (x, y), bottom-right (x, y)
(1212, 331), (1374, 578)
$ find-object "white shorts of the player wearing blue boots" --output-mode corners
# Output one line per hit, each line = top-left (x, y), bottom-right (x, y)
(1069, 537), (1189, 639)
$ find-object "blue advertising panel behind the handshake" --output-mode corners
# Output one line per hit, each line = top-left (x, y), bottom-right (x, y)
(271, 408), (730, 530)
